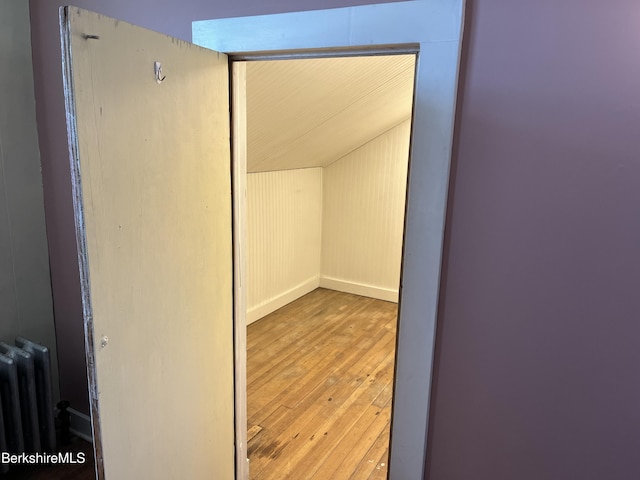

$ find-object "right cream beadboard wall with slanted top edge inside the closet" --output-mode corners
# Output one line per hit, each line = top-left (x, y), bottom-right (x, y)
(320, 120), (411, 301)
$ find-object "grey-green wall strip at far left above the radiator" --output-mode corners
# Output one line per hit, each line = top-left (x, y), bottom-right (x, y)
(0, 0), (59, 398)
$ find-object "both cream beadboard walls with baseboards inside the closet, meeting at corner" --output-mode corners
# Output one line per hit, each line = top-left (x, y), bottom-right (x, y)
(247, 120), (410, 323)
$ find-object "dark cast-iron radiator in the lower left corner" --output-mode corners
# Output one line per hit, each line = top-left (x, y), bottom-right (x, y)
(0, 337), (56, 464)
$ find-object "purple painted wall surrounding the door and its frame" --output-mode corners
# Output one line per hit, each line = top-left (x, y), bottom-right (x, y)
(31, 0), (640, 480)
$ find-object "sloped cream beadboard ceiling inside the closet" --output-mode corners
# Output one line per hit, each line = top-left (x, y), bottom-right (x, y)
(247, 55), (415, 172)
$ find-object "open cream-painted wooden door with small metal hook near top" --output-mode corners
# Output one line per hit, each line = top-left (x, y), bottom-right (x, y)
(61, 7), (234, 480)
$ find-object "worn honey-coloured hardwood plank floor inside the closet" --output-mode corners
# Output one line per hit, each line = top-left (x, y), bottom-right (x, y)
(247, 289), (397, 480)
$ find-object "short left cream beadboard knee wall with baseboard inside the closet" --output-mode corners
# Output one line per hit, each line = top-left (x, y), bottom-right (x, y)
(247, 168), (322, 323)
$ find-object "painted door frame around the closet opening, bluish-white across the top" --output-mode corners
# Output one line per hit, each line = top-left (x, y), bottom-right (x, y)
(193, 0), (465, 480)
